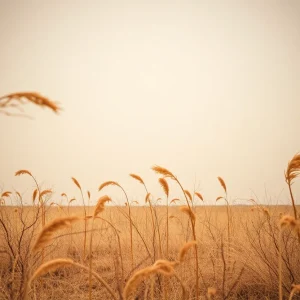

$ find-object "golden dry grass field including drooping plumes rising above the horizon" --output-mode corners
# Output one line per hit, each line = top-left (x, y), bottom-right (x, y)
(0, 159), (300, 300)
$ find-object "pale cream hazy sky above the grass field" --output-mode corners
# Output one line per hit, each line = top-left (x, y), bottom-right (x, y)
(0, 0), (300, 203)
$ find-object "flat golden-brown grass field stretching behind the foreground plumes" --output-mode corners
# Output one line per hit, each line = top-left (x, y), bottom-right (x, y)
(0, 197), (300, 299)
